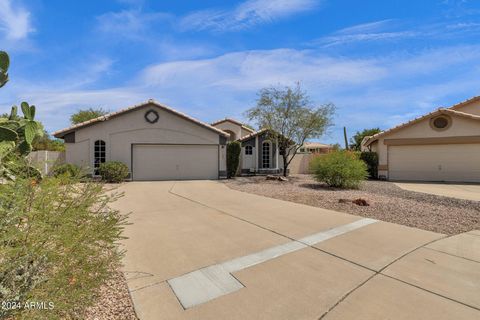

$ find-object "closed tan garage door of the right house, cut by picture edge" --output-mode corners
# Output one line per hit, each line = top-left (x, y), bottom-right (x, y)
(388, 144), (480, 182)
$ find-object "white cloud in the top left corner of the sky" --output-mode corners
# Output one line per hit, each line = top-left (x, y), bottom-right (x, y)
(0, 0), (34, 40)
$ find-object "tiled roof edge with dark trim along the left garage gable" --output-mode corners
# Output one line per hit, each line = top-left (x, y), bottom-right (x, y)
(53, 99), (230, 138)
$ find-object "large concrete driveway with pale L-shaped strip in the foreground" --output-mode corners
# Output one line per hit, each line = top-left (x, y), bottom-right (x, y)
(115, 181), (480, 320)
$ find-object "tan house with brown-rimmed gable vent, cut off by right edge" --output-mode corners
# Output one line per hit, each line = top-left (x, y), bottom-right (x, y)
(362, 96), (480, 182)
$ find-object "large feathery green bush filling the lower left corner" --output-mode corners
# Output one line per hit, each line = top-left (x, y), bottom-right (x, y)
(0, 175), (126, 320)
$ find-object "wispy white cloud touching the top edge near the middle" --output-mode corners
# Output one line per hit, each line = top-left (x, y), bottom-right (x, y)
(180, 0), (320, 31)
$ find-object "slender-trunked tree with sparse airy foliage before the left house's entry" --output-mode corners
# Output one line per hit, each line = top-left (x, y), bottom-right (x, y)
(246, 83), (335, 176)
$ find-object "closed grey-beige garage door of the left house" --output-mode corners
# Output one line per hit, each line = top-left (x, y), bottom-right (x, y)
(132, 145), (218, 180)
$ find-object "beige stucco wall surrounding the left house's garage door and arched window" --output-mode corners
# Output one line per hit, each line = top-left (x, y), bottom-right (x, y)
(66, 105), (226, 175)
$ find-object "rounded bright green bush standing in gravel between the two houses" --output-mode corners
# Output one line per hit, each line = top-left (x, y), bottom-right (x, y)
(310, 150), (367, 189)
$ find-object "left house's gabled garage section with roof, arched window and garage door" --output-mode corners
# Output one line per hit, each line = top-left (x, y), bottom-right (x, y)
(53, 100), (229, 180)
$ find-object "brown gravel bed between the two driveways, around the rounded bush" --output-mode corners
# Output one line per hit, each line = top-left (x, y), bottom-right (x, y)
(225, 175), (480, 235)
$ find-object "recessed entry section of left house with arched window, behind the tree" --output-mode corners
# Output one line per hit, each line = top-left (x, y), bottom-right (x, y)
(212, 119), (283, 174)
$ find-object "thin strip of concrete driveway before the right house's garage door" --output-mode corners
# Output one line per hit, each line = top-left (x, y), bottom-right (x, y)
(395, 182), (480, 201)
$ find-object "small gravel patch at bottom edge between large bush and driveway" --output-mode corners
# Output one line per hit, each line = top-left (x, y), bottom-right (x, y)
(85, 270), (138, 320)
